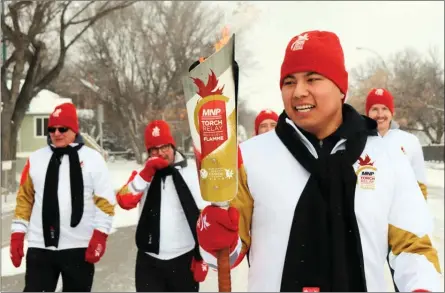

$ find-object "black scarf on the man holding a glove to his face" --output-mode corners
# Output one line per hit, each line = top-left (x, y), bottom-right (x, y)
(136, 156), (202, 261)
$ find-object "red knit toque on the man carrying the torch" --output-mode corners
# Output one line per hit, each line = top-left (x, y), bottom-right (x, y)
(280, 31), (348, 95)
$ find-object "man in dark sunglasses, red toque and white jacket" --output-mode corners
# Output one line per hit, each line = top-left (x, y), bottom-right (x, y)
(10, 103), (116, 292)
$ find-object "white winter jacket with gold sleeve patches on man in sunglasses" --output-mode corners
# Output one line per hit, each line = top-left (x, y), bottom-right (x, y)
(11, 144), (116, 250)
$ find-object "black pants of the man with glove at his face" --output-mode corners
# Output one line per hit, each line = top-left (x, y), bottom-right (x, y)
(136, 250), (199, 292)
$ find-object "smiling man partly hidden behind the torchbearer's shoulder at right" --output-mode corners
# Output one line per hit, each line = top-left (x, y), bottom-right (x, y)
(365, 88), (428, 199)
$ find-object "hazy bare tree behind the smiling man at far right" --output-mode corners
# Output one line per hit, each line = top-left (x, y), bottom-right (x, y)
(349, 49), (444, 143)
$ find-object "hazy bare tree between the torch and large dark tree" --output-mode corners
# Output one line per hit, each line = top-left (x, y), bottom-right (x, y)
(74, 1), (225, 162)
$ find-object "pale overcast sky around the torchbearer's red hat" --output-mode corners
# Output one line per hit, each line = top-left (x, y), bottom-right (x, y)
(213, 1), (444, 112)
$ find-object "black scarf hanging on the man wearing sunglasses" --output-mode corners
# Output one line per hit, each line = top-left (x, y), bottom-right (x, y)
(42, 137), (84, 247)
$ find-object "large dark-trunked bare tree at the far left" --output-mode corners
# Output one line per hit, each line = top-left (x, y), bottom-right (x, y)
(1, 0), (134, 171)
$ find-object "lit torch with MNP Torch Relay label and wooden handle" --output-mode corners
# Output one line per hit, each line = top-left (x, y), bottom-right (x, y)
(183, 28), (239, 292)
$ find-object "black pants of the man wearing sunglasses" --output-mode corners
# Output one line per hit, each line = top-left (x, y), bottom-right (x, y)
(24, 248), (94, 292)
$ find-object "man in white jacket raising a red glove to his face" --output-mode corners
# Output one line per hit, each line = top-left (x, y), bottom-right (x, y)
(117, 120), (208, 292)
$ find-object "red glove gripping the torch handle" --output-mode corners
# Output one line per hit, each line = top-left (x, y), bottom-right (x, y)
(196, 206), (239, 257)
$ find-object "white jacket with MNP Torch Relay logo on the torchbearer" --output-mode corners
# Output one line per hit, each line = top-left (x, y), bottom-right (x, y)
(202, 120), (441, 292)
